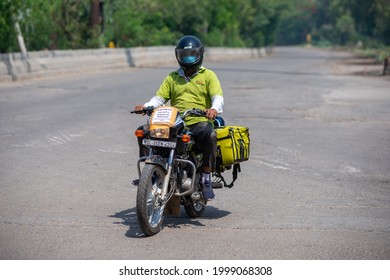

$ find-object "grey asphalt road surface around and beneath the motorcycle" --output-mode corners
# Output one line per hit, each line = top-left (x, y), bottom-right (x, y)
(0, 48), (390, 260)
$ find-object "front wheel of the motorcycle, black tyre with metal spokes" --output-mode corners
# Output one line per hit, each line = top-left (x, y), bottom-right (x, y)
(137, 164), (165, 236)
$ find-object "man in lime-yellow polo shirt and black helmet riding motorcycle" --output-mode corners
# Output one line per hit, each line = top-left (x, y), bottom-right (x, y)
(134, 35), (224, 199)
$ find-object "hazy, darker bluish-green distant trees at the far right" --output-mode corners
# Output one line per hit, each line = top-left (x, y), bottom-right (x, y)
(278, 0), (390, 45)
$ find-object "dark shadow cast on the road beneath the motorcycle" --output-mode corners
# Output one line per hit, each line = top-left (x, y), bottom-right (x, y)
(109, 206), (231, 238)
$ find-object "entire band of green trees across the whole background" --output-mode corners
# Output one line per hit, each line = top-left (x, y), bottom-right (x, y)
(0, 0), (390, 52)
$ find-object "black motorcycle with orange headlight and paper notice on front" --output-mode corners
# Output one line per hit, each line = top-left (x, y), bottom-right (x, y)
(131, 106), (223, 236)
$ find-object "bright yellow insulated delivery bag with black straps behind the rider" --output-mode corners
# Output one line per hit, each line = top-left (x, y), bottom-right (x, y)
(215, 126), (250, 167)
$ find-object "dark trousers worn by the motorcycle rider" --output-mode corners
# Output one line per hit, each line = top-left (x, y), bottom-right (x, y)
(138, 122), (217, 171)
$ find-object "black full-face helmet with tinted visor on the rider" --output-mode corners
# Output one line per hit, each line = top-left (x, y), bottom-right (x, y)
(175, 35), (204, 70)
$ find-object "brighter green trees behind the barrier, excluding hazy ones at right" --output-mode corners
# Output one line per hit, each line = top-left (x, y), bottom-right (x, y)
(0, 0), (288, 52)
